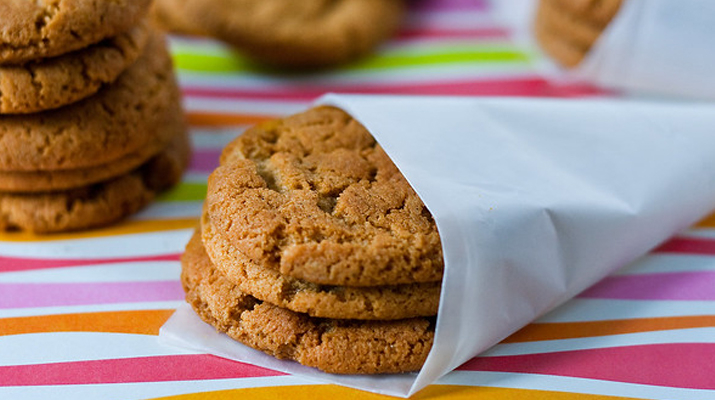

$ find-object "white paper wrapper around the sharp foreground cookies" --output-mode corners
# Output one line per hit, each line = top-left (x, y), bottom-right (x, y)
(161, 95), (715, 396)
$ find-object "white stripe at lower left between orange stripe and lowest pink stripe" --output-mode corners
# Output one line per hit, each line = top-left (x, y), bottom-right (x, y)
(0, 332), (199, 366)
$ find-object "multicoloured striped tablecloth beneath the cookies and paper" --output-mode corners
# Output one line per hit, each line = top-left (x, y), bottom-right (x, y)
(0, 0), (715, 400)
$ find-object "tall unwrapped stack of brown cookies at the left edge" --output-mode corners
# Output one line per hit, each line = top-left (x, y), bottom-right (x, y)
(0, 0), (190, 233)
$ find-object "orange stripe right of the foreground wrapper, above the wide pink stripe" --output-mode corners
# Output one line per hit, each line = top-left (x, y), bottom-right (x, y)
(503, 315), (715, 343)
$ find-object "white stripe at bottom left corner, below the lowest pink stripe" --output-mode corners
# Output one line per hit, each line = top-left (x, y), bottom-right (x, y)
(0, 375), (319, 400)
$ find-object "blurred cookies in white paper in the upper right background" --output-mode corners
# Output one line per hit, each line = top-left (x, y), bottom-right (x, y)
(532, 0), (715, 100)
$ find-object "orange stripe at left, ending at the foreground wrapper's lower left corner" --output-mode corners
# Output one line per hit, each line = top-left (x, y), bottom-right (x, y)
(0, 310), (174, 336)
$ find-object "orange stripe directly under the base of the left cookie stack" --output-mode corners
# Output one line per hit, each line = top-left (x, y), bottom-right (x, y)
(0, 218), (198, 242)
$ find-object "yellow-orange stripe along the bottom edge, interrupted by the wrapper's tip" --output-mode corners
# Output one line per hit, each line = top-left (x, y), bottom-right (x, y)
(148, 385), (632, 400)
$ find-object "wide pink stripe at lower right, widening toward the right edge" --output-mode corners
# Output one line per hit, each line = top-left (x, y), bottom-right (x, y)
(458, 343), (715, 389)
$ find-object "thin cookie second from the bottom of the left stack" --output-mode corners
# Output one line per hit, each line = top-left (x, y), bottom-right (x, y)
(0, 96), (186, 193)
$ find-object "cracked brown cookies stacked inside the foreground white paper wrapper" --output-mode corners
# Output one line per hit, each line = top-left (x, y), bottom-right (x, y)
(182, 107), (443, 374)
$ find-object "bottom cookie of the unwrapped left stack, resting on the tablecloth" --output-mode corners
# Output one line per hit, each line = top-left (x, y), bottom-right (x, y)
(0, 124), (190, 233)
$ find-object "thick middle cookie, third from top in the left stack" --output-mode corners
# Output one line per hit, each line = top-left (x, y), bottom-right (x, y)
(0, 28), (179, 172)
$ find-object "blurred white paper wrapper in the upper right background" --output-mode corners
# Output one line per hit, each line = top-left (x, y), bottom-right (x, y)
(495, 0), (715, 100)
